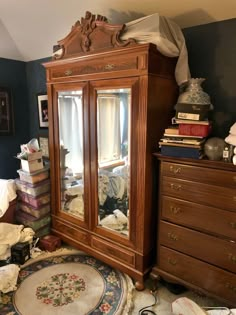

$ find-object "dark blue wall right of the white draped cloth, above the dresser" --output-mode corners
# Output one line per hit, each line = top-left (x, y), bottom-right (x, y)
(183, 19), (236, 138)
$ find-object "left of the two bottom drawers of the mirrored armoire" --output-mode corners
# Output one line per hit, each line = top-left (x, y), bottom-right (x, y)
(53, 219), (89, 245)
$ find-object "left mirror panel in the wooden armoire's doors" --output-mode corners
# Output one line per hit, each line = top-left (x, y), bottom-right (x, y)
(58, 90), (84, 220)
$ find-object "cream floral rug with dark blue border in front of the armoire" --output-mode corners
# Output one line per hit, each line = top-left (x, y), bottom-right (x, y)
(0, 254), (132, 315)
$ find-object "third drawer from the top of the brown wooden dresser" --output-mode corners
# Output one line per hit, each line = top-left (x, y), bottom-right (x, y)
(161, 196), (236, 241)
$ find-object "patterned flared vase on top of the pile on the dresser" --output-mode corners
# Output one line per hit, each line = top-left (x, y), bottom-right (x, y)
(178, 78), (211, 105)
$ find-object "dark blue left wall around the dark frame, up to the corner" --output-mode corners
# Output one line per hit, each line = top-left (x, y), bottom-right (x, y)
(0, 58), (30, 179)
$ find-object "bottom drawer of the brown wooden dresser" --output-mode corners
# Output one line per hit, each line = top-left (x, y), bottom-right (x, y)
(158, 246), (236, 304)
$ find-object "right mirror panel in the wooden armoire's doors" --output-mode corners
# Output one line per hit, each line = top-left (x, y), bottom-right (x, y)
(97, 88), (131, 236)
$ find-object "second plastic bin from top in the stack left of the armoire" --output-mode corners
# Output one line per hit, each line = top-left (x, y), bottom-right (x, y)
(15, 178), (50, 196)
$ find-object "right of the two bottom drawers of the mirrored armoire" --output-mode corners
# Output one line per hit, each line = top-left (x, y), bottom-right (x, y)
(91, 236), (135, 267)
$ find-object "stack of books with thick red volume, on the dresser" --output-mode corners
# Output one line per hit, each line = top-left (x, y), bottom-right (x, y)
(159, 117), (212, 159)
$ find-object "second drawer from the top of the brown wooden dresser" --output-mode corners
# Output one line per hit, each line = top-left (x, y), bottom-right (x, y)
(161, 176), (236, 212)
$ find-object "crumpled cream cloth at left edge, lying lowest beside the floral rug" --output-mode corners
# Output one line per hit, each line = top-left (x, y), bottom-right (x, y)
(0, 264), (20, 293)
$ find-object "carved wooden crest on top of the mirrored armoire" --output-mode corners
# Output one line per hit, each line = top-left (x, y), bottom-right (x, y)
(53, 11), (135, 59)
